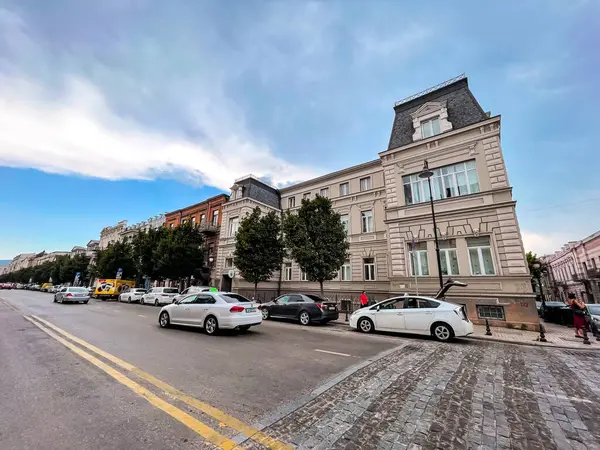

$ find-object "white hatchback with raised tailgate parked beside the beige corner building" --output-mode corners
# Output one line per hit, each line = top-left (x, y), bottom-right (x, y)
(350, 296), (473, 341)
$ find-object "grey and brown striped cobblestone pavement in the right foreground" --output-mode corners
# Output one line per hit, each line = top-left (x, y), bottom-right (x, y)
(242, 341), (600, 450)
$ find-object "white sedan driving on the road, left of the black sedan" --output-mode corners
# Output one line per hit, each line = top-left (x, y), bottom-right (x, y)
(158, 292), (262, 335)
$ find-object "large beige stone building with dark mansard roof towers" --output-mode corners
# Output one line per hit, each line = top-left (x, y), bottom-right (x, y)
(217, 76), (538, 329)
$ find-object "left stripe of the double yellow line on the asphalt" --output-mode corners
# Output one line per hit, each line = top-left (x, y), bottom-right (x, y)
(24, 316), (237, 450)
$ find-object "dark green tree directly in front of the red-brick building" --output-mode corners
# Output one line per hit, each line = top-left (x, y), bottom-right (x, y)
(156, 223), (204, 280)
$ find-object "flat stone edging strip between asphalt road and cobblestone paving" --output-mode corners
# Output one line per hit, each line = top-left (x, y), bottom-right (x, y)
(232, 343), (408, 445)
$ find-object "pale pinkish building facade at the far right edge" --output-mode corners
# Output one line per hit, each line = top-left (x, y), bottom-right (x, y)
(540, 231), (600, 303)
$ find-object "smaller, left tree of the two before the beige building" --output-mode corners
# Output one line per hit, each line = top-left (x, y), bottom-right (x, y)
(233, 207), (285, 298)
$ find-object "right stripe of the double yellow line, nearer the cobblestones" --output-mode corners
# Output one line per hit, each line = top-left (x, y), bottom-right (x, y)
(31, 316), (293, 450)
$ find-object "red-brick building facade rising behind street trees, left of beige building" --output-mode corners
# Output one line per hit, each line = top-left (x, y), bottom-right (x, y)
(164, 194), (229, 285)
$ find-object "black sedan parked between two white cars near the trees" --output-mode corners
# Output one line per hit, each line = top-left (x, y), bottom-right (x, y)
(262, 294), (339, 325)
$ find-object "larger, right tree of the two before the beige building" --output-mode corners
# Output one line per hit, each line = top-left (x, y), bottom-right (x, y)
(283, 196), (348, 295)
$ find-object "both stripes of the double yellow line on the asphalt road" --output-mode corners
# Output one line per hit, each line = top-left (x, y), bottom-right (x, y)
(24, 315), (292, 450)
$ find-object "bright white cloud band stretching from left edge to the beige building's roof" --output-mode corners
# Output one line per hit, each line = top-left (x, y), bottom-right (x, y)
(0, 76), (317, 189)
